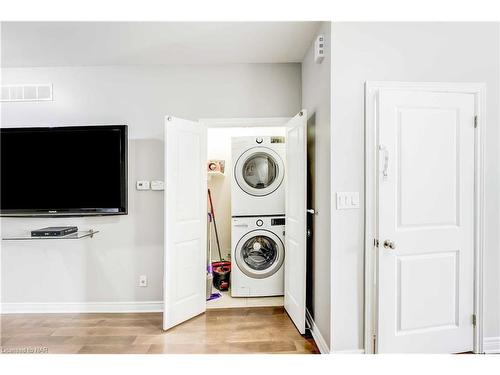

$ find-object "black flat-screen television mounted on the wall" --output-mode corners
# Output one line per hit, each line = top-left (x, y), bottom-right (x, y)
(0, 125), (127, 216)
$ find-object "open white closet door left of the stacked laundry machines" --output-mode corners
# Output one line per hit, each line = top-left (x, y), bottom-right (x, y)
(163, 117), (207, 330)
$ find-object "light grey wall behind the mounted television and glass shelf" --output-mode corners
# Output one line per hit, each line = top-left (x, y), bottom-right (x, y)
(1, 64), (301, 310)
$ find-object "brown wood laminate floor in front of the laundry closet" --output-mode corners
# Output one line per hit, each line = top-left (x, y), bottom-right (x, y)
(1, 307), (319, 354)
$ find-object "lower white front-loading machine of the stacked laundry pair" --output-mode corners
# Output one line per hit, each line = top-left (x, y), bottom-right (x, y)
(231, 216), (285, 297)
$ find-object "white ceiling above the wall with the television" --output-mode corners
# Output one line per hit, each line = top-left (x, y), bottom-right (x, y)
(1, 22), (319, 67)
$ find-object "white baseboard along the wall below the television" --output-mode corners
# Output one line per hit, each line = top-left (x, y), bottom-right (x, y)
(0, 301), (163, 314)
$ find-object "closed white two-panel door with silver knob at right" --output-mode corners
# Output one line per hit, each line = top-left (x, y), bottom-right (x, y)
(377, 89), (475, 353)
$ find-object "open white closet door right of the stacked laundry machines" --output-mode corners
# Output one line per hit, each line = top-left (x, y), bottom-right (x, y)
(285, 110), (307, 334)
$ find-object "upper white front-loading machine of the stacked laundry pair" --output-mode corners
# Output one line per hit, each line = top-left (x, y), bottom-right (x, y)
(231, 136), (285, 216)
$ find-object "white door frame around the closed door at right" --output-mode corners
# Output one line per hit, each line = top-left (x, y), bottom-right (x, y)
(364, 81), (486, 353)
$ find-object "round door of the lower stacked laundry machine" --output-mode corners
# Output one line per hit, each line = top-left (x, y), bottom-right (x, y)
(235, 230), (285, 279)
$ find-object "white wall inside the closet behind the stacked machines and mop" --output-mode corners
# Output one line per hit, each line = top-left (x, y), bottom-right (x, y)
(207, 126), (285, 261)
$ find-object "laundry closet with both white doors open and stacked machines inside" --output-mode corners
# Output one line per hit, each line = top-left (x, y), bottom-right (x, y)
(163, 110), (307, 333)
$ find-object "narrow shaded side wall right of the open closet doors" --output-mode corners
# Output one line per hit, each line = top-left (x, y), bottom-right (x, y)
(302, 22), (335, 348)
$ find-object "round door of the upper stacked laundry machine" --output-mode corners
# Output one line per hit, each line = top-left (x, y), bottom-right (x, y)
(234, 147), (285, 196)
